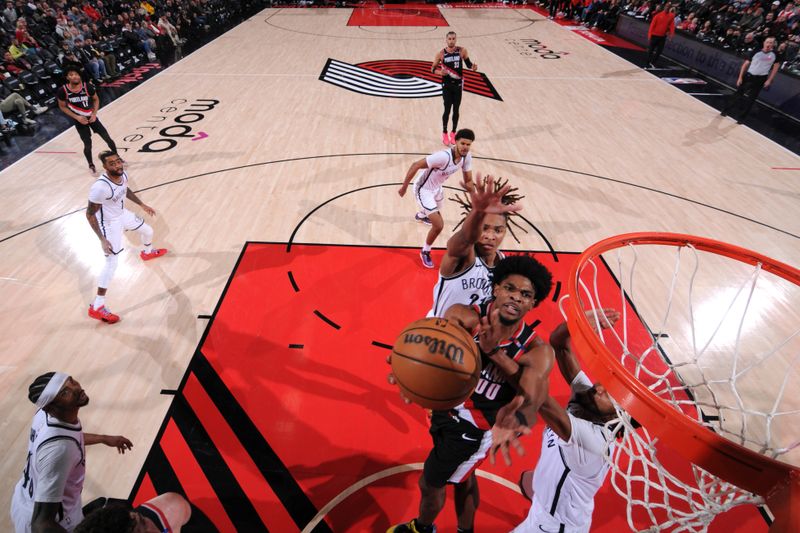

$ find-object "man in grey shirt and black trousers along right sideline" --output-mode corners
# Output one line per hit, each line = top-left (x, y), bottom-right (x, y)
(720, 37), (783, 124)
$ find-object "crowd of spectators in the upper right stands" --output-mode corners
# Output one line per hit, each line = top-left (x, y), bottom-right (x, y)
(622, 0), (800, 75)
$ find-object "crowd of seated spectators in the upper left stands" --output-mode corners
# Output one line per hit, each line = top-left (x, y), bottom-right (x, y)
(0, 0), (269, 144)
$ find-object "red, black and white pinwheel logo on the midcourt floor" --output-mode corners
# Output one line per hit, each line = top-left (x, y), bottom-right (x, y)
(319, 59), (503, 101)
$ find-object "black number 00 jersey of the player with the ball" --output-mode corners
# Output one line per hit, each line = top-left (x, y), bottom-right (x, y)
(454, 301), (536, 430)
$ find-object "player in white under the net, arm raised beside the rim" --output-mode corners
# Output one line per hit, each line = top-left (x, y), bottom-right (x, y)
(488, 309), (632, 533)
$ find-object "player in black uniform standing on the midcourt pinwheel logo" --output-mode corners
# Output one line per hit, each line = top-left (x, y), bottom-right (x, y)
(431, 31), (478, 146)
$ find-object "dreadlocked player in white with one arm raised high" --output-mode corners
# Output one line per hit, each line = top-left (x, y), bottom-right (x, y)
(427, 174), (522, 317)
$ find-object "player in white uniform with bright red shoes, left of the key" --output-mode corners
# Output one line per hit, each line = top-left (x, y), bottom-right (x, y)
(86, 152), (167, 324)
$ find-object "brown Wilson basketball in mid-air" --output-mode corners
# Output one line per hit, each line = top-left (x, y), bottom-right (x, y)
(392, 318), (481, 409)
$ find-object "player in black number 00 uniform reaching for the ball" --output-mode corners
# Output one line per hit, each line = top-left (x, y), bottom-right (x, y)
(387, 255), (555, 533)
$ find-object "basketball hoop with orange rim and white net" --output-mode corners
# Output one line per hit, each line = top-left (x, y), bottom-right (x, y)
(561, 233), (800, 533)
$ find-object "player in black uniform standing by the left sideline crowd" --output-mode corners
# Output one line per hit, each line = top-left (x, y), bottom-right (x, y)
(56, 64), (117, 174)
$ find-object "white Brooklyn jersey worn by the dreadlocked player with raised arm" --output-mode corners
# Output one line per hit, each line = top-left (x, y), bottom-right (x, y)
(427, 252), (505, 318)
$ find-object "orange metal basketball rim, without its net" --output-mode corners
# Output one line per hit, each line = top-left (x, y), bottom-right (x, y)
(565, 233), (800, 533)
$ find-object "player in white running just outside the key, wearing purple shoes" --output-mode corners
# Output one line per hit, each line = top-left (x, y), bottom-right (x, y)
(397, 129), (475, 268)
